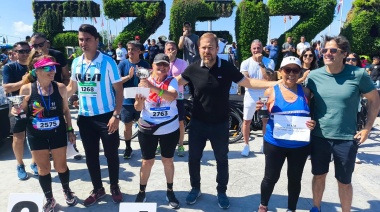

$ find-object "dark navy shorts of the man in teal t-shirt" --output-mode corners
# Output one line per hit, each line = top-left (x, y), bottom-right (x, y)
(310, 136), (359, 184)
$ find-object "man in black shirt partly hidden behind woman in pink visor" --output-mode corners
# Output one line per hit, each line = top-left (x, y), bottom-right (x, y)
(30, 32), (70, 86)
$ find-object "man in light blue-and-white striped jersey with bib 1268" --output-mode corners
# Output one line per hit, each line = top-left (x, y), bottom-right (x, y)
(67, 24), (123, 207)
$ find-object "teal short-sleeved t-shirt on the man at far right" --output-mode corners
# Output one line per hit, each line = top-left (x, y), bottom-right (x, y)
(306, 65), (375, 140)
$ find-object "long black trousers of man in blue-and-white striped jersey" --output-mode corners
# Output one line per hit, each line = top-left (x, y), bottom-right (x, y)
(77, 112), (120, 189)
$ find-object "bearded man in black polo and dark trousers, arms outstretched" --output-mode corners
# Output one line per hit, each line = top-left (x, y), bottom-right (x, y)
(176, 33), (277, 209)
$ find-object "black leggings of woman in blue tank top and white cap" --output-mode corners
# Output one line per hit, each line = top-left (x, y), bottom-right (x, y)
(261, 141), (310, 210)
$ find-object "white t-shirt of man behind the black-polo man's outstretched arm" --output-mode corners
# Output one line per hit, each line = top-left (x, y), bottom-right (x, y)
(240, 57), (275, 99)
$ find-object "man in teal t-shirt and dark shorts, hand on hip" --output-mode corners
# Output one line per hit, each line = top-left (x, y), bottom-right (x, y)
(307, 36), (380, 212)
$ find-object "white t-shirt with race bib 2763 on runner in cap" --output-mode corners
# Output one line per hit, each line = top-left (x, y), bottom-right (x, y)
(140, 78), (179, 135)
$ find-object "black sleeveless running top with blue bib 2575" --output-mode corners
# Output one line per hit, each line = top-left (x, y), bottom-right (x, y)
(27, 82), (66, 133)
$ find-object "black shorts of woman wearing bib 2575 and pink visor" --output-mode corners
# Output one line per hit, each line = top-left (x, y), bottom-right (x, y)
(26, 124), (67, 151)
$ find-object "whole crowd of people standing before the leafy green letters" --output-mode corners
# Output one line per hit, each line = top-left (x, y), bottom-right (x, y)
(1, 22), (380, 212)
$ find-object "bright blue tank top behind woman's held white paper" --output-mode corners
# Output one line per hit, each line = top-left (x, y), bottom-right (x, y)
(264, 85), (310, 148)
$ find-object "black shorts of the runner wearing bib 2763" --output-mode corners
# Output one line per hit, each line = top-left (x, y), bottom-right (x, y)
(138, 129), (179, 160)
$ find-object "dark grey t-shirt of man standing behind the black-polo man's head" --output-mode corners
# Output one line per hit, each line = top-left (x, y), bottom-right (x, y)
(181, 34), (200, 65)
